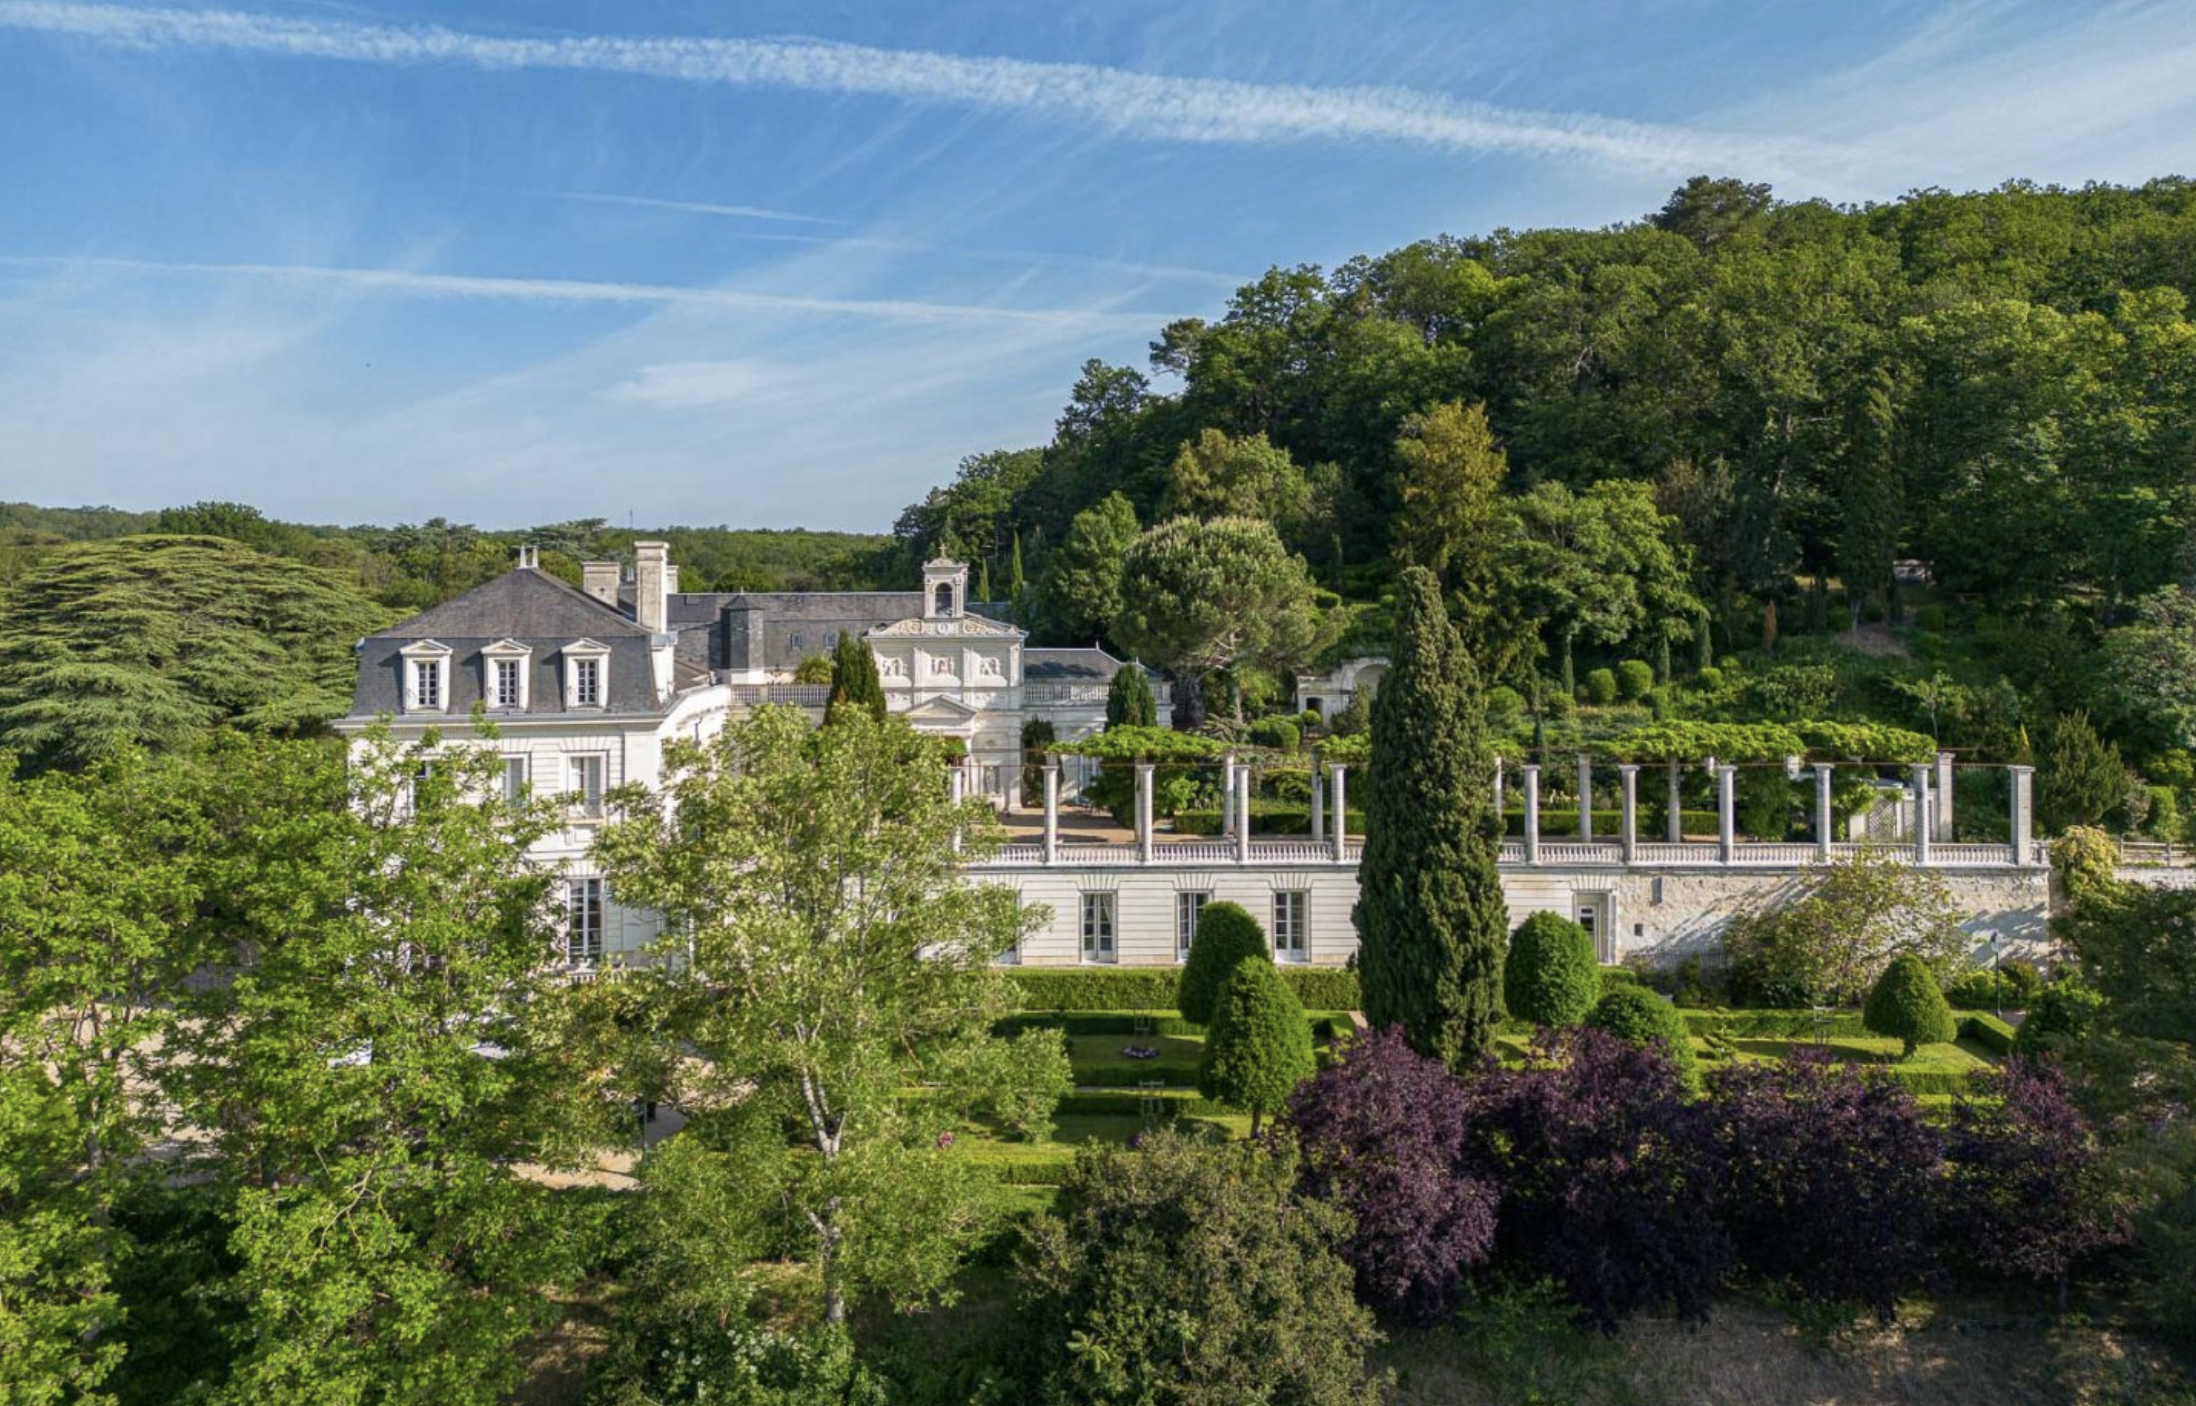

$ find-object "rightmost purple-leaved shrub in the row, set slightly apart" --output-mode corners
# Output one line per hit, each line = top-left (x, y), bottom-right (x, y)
(1946, 1059), (2130, 1307)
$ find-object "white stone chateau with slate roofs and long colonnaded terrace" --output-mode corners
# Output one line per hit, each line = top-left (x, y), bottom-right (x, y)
(338, 543), (2049, 971)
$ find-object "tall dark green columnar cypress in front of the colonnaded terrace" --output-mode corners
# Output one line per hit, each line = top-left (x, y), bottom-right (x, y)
(1351, 567), (1509, 1070)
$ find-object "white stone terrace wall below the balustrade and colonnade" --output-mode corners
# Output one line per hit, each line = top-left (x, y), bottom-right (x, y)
(971, 863), (2051, 967)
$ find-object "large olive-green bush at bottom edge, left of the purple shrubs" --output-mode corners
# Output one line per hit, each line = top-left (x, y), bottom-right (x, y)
(1012, 1129), (1386, 1406)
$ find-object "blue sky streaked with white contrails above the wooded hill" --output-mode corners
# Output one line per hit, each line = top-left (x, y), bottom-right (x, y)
(0, 0), (2196, 529)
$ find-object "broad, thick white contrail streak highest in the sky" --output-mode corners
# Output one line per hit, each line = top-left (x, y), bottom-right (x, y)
(0, 0), (1836, 171)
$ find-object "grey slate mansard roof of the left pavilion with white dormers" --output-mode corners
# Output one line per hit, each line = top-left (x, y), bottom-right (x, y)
(351, 569), (709, 718)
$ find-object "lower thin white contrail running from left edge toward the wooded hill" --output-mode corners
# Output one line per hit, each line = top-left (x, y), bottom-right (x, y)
(0, 255), (1166, 330)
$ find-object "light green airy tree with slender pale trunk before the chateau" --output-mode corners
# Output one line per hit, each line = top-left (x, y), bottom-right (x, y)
(595, 707), (1043, 1323)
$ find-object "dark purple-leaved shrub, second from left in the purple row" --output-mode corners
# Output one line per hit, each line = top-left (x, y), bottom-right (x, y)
(1467, 1030), (1730, 1331)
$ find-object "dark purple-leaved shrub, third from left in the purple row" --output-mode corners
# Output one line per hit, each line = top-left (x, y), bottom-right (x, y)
(1708, 1048), (1941, 1323)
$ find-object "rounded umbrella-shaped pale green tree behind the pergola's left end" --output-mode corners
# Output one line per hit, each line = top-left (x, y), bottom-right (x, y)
(1113, 518), (1324, 723)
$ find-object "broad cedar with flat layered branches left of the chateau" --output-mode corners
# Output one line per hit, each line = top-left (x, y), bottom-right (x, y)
(0, 536), (386, 769)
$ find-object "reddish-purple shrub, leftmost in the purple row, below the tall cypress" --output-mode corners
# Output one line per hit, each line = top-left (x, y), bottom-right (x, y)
(1289, 1026), (1500, 1323)
